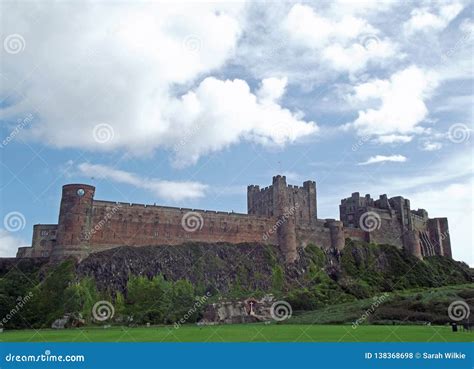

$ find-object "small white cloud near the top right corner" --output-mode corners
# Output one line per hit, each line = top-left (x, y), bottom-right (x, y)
(404, 2), (463, 35)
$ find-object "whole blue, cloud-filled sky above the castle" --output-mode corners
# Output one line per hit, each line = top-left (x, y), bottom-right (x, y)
(0, 0), (474, 265)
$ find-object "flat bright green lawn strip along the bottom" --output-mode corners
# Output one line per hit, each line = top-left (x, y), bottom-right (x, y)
(0, 324), (474, 342)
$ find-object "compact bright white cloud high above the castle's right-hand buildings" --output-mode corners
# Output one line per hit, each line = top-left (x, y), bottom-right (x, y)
(347, 66), (438, 136)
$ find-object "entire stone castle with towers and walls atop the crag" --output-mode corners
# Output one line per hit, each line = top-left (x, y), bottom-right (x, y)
(17, 175), (451, 262)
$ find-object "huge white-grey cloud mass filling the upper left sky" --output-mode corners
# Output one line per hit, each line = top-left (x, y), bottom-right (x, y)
(0, 2), (317, 165)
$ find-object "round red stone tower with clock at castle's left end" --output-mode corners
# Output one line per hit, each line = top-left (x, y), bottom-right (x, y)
(51, 184), (95, 259)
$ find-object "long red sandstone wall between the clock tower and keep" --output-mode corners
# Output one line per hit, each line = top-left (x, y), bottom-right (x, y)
(86, 201), (277, 251)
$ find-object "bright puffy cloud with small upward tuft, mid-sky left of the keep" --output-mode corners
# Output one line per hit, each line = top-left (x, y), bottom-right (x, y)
(169, 77), (318, 166)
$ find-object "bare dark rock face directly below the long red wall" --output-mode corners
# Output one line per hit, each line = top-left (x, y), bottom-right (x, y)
(77, 243), (304, 293)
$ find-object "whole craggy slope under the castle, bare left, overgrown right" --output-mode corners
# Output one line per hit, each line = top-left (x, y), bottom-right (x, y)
(76, 242), (471, 301)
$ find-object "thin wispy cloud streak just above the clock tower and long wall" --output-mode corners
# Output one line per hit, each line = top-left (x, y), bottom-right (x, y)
(77, 163), (208, 201)
